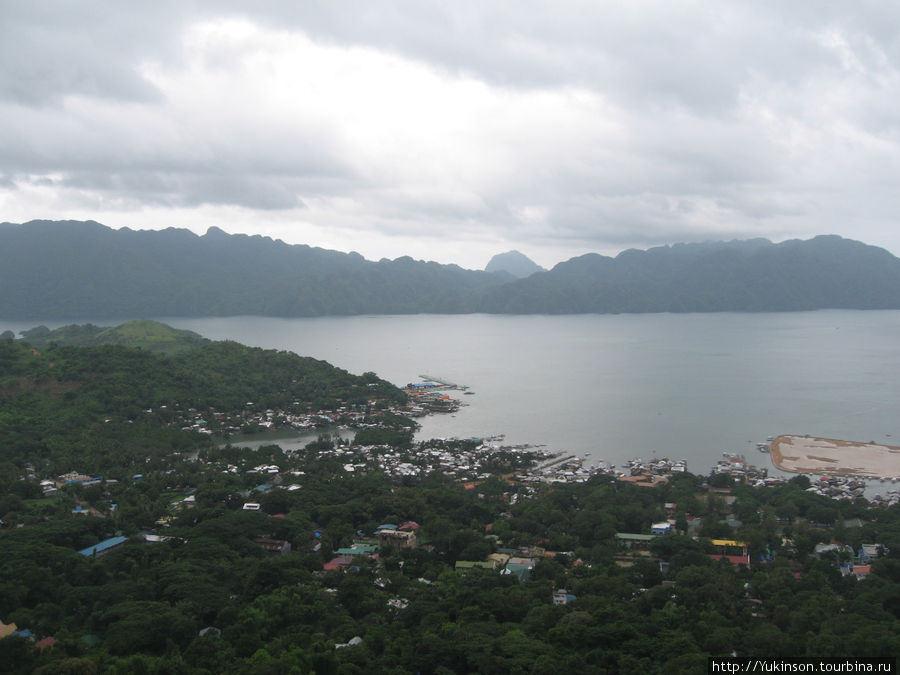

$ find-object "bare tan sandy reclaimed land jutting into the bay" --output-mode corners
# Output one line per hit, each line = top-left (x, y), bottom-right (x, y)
(770, 436), (900, 480)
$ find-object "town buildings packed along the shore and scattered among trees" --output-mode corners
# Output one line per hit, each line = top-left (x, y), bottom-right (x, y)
(30, 410), (897, 580)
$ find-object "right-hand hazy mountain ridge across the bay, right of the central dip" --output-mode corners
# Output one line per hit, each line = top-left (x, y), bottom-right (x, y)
(482, 236), (900, 314)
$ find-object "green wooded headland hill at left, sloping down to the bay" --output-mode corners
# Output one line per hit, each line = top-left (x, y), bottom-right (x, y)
(0, 340), (406, 472)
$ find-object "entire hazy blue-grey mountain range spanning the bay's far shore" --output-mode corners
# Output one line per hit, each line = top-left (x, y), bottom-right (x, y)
(0, 221), (900, 319)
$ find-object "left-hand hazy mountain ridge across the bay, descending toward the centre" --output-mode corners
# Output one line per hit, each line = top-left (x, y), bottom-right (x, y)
(0, 221), (508, 319)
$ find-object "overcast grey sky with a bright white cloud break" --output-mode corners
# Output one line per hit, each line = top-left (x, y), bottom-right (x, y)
(0, 0), (900, 268)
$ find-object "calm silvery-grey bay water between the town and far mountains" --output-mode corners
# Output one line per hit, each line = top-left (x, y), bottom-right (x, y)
(7, 310), (900, 473)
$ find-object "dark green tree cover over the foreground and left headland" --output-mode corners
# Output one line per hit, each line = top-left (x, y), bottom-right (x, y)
(0, 340), (900, 673)
